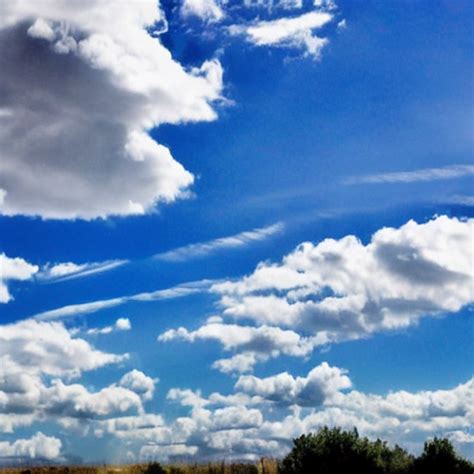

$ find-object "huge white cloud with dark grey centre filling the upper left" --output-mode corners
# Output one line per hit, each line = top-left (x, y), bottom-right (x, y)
(0, 0), (222, 219)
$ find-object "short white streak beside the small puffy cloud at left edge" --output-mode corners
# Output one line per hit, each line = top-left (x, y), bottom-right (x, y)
(37, 260), (128, 282)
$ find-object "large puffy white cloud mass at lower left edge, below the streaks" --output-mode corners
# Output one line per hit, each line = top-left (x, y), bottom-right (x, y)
(0, 320), (158, 432)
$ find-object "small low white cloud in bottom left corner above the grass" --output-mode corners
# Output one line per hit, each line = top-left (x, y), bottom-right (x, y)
(0, 432), (62, 460)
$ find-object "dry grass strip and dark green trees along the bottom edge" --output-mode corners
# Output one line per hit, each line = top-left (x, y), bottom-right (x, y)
(0, 427), (474, 474)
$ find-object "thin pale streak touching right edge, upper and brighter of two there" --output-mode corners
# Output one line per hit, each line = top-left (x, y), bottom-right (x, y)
(343, 165), (474, 184)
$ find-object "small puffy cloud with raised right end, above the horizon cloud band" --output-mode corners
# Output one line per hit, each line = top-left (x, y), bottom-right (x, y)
(235, 362), (351, 406)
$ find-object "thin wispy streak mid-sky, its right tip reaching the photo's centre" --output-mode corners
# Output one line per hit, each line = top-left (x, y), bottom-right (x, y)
(155, 222), (284, 262)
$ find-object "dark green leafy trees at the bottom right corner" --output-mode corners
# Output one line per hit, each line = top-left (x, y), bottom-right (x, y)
(278, 427), (474, 474)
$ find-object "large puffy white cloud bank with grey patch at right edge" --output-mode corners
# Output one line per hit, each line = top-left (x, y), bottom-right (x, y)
(213, 216), (474, 343)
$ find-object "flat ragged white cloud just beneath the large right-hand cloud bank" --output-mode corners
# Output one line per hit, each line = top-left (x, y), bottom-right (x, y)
(158, 322), (315, 372)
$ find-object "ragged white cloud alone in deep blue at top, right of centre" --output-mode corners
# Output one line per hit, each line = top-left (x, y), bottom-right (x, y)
(229, 10), (334, 59)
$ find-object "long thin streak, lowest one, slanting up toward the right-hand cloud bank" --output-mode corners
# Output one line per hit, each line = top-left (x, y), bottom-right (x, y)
(32, 279), (219, 321)
